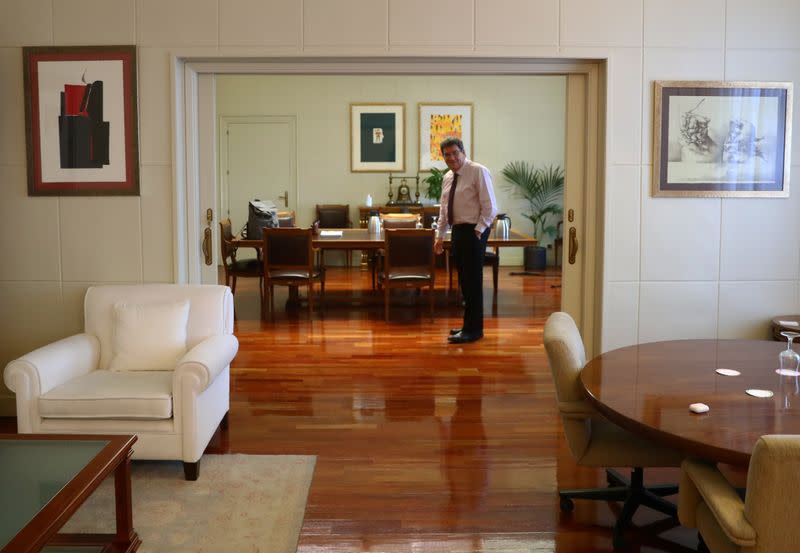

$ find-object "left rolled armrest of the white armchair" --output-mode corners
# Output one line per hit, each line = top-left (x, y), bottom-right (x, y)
(4, 334), (100, 397)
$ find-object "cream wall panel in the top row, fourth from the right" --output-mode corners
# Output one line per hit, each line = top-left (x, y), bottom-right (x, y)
(389, 0), (475, 48)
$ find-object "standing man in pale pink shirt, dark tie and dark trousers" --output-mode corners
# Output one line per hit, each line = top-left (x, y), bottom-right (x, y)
(433, 138), (497, 344)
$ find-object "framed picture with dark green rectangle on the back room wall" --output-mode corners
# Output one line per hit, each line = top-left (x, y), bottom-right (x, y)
(350, 103), (406, 173)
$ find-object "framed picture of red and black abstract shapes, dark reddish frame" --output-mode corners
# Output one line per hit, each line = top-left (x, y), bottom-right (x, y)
(22, 46), (139, 196)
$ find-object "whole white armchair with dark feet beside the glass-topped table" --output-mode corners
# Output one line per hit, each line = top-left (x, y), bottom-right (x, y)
(4, 284), (239, 480)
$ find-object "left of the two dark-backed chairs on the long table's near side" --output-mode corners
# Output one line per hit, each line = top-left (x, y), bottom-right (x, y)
(261, 227), (325, 314)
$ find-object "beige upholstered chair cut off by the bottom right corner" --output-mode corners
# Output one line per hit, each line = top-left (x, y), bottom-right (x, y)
(678, 435), (800, 553)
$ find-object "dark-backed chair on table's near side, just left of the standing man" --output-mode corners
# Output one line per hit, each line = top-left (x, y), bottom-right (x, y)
(379, 229), (436, 321)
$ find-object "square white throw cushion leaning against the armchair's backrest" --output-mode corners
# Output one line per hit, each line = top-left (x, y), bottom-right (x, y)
(109, 300), (189, 371)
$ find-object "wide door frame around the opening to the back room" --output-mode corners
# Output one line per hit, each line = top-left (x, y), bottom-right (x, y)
(170, 52), (607, 356)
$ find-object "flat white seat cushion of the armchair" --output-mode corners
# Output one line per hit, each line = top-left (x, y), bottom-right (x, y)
(39, 370), (172, 420)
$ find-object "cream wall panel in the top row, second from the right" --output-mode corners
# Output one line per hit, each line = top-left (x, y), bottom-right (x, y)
(644, 0), (725, 48)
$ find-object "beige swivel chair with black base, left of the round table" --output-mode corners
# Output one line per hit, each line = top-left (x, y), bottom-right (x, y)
(544, 312), (683, 550)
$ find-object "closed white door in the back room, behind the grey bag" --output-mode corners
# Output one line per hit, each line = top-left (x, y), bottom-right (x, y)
(219, 116), (297, 249)
